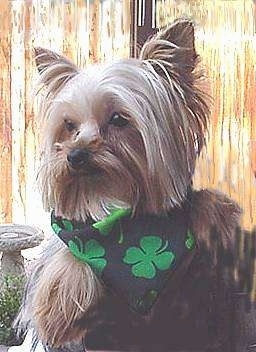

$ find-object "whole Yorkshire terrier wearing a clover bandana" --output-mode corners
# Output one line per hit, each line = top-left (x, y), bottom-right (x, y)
(19, 19), (256, 352)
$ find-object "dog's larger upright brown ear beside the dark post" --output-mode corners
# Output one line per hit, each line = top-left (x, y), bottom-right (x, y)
(140, 19), (197, 74)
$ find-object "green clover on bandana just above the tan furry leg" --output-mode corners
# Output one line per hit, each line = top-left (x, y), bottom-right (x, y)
(68, 237), (107, 274)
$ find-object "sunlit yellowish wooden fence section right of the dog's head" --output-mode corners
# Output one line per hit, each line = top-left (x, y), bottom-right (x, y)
(157, 0), (256, 229)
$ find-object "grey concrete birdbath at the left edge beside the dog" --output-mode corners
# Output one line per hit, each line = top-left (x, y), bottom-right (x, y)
(0, 224), (44, 281)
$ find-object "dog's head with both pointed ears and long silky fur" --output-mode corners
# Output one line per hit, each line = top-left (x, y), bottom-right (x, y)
(36, 20), (208, 220)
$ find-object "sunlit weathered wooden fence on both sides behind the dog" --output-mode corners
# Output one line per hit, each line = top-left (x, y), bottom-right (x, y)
(0, 0), (256, 229)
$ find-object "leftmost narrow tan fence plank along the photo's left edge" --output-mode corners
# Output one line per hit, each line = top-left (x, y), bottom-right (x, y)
(0, 1), (12, 222)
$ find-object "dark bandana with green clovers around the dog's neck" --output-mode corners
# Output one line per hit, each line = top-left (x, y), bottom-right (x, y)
(51, 209), (195, 314)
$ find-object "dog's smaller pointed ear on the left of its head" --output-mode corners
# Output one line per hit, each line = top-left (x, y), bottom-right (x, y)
(34, 47), (79, 93)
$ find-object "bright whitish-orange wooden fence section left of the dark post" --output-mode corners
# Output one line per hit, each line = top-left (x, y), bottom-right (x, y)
(0, 0), (131, 225)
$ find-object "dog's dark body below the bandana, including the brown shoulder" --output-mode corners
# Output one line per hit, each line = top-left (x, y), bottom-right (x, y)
(73, 191), (244, 352)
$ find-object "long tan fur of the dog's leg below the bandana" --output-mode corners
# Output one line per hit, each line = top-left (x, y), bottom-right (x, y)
(32, 248), (101, 347)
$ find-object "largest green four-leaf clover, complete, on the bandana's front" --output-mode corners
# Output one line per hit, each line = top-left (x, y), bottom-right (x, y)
(123, 236), (175, 279)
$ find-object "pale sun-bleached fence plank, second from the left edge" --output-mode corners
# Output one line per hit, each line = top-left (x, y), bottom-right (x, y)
(11, 0), (26, 222)
